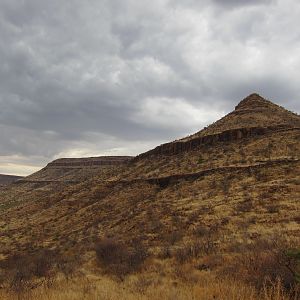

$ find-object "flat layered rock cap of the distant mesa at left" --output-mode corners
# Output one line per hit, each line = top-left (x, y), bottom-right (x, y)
(47, 156), (132, 167)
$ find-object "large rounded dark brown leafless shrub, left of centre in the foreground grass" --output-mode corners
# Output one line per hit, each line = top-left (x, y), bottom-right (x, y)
(95, 238), (148, 279)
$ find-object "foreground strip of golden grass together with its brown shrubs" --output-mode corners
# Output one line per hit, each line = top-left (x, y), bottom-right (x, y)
(0, 239), (300, 300)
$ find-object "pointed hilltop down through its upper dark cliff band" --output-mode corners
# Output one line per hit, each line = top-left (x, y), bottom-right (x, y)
(140, 94), (300, 157)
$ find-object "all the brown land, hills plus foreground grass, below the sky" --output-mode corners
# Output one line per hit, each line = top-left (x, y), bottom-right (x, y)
(0, 94), (300, 300)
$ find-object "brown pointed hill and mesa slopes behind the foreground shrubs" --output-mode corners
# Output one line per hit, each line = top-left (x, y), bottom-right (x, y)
(0, 94), (300, 282)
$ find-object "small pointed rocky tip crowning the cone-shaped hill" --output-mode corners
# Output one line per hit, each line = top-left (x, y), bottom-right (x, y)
(235, 93), (282, 112)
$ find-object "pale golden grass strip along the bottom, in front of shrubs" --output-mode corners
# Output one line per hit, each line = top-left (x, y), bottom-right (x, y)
(0, 274), (297, 300)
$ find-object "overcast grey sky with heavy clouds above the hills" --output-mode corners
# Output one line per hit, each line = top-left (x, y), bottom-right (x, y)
(0, 0), (300, 175)
